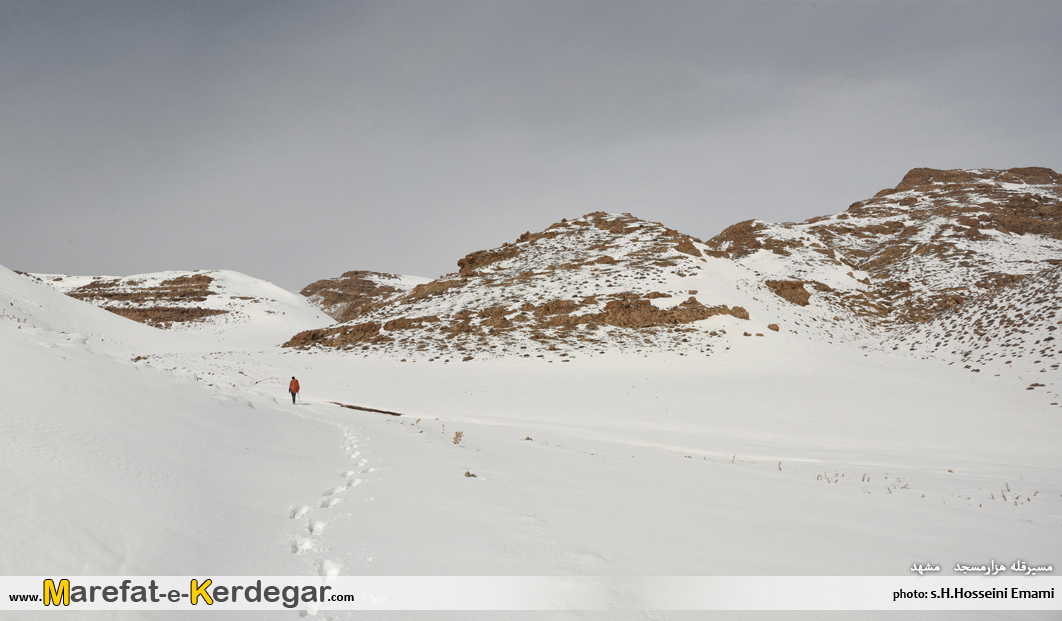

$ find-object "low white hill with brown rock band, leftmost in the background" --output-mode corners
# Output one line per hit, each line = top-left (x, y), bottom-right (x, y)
(34, 270), (332, 348)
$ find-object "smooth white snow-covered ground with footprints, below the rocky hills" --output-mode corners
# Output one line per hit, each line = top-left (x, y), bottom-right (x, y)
(0, 264), (1062, 619)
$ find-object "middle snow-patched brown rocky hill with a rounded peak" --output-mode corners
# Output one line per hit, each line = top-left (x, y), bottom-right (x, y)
(289, 212), (879, 361)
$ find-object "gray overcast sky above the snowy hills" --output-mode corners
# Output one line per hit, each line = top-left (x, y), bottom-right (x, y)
(0, 0), (1062, 291)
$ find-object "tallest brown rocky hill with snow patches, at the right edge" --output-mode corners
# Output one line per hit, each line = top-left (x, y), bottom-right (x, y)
(708, 168), (1062, 323)
